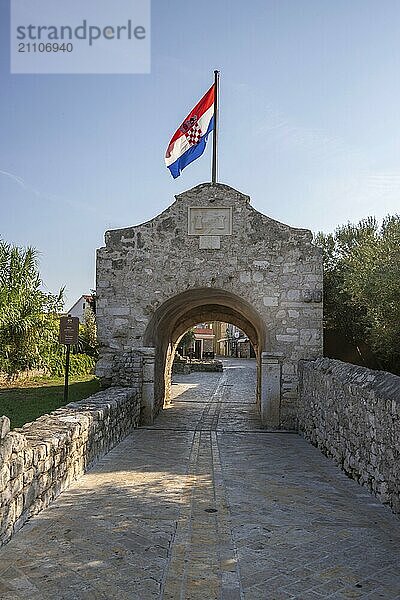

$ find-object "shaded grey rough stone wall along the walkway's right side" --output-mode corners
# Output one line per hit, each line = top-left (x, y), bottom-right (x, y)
(299, 358), (400, 513)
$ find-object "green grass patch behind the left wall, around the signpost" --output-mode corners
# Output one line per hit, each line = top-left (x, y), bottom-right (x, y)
(0, 375), (100, 428)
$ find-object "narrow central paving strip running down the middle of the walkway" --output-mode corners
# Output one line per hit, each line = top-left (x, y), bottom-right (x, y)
(161, 373), (242, 600)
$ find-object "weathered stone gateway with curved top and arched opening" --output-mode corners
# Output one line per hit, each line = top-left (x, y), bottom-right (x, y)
(97, 183), (323, 429)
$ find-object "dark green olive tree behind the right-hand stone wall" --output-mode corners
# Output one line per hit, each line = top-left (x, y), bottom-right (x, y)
(315, 215), (400, 373)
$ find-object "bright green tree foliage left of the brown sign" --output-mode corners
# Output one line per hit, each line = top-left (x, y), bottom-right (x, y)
(0, 240), (63, 375)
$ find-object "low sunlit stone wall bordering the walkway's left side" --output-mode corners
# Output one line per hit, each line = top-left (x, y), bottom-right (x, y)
(0, 388), (140, 546)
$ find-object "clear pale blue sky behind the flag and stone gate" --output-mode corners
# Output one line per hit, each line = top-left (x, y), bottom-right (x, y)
(0, 0), (400, 308)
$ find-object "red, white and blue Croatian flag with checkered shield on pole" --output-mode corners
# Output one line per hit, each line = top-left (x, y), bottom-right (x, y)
(165, 84), (215, 179)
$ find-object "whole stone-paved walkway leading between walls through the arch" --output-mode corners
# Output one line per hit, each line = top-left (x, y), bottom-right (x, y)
(0, 360), (400, 600)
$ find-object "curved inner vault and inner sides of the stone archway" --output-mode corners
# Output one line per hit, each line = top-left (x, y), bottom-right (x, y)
(144, 288), (269, 416)
